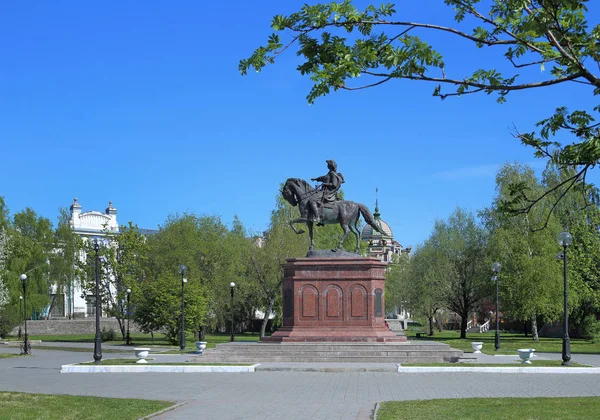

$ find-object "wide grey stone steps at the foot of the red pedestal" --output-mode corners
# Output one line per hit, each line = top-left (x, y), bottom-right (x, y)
(190, 342), (463, 363)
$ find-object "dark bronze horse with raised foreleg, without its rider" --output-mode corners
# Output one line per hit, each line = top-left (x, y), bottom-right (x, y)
(281, 178), (385, 253)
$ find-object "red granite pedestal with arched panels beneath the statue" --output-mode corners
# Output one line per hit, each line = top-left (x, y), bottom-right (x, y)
(262, 257), (406, 342)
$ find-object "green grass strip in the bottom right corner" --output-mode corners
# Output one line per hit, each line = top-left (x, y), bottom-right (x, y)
(377, 397), (600, 420)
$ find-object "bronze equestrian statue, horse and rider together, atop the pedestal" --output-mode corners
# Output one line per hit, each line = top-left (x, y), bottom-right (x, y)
(281, 160), (385, 254)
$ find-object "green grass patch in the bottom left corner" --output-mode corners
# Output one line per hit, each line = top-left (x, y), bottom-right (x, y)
(0, 392), (173, 420)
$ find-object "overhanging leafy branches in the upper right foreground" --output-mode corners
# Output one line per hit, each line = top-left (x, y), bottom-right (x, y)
(239, 0), (600, 217)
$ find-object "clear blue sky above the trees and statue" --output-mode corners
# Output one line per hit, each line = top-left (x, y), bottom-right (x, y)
(0, 0), (599, 245)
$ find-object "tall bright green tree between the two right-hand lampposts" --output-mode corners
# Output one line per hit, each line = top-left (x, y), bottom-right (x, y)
(482, 164), (563, 340)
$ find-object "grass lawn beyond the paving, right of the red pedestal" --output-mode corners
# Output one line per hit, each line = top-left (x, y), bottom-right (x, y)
(406, 331), (600, 354)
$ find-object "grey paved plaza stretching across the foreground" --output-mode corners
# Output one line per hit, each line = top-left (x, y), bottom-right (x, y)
(0, 347), (600, 419)
